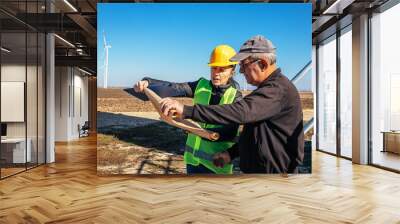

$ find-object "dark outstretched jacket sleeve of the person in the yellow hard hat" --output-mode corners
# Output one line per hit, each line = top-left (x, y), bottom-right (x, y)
(142, 77), (198, 98)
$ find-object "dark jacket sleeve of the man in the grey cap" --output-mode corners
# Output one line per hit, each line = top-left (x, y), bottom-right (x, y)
(183, 84), (285, 124)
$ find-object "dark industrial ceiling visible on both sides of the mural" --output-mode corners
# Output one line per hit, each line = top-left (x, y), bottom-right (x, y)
(0, 0), (394, 74)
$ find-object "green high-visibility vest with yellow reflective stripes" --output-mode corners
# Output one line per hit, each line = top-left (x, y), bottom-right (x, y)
(184, 78), (239, 174)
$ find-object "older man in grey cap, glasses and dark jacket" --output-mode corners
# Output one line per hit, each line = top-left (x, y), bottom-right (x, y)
(162, 35), (304, 173)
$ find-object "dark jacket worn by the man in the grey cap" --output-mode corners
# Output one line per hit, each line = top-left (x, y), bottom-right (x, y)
(183, 69), (304, 173)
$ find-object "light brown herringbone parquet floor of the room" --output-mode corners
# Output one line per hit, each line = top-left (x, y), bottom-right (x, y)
(0, 137), (400, 224)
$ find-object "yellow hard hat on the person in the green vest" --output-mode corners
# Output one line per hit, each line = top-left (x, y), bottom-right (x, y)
(208, 45), (238, 67)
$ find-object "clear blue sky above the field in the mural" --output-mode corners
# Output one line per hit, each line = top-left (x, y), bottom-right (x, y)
(97, 3), (311, 87)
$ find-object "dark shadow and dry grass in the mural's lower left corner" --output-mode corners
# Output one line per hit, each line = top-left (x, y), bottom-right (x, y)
(97, 122), (185, 175)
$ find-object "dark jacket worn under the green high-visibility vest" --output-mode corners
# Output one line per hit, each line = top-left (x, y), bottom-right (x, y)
(142, 77), (242, 141)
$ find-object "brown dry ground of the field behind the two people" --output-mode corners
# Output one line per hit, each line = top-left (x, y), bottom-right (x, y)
(97, 88), (313, 175)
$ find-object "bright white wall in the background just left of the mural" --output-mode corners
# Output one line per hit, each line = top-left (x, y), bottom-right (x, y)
(55, 67), (88, 141)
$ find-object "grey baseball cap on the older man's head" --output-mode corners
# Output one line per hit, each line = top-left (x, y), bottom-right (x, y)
(230, 35), (276, 62)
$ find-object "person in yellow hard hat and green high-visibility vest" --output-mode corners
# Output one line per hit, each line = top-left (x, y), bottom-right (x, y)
(134, 45), (242, 174)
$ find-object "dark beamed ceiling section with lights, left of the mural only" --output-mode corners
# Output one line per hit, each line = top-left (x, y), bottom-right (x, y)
(0, 0), (97, 74)
